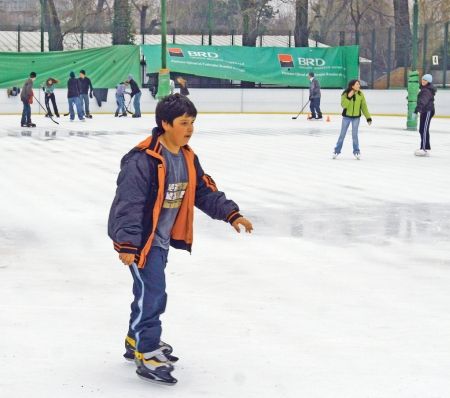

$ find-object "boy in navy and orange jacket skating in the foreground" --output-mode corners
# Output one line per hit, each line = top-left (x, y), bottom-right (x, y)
(108, 94), (253, 384)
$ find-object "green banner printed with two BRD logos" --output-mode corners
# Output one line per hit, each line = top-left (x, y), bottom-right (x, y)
(141, 44), (359, 88)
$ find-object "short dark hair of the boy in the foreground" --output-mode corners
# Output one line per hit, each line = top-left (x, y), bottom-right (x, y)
(155, 93), (197, 131)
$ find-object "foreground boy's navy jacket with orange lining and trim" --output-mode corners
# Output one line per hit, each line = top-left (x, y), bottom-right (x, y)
(108, 128), (242, 268)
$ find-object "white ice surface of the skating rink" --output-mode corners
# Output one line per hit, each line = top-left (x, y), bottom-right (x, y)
(0, 115), (450, 398)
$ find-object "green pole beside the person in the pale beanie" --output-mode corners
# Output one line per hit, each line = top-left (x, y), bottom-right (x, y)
(406, 0), (419, 131)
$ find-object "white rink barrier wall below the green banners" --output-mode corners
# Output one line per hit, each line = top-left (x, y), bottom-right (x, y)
(0, 88), (450, 117)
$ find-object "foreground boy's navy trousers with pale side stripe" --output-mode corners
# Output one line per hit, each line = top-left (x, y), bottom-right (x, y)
(128, 246), (169, 352)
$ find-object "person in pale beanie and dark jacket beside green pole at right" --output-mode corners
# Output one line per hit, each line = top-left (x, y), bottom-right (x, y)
(414, 74), (436, 156)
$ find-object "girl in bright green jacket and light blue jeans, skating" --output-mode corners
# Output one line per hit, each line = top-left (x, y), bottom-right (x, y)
(333, 80), (372, 160)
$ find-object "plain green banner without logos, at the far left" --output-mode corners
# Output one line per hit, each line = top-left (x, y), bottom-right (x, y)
(0, 46), (141, 88)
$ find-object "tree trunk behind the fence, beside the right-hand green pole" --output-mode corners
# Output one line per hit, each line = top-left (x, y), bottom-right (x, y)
(393, 0), (411, 67)
